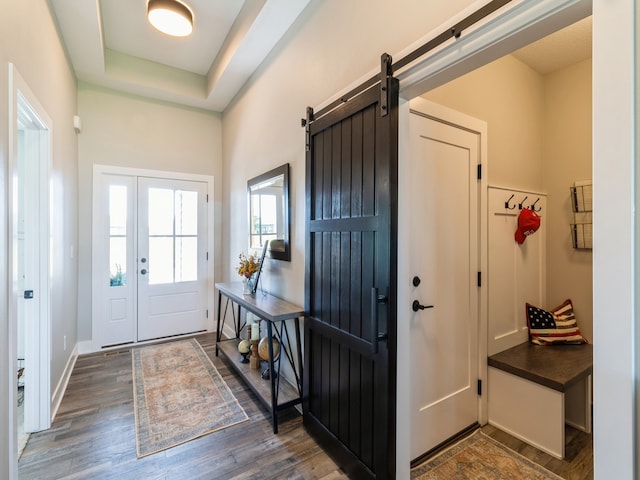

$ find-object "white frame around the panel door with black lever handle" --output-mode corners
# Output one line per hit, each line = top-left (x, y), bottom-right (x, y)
(396, 98), (488, 462)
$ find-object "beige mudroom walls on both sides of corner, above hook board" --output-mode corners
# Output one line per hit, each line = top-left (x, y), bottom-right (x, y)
(424, 56), (593, 340)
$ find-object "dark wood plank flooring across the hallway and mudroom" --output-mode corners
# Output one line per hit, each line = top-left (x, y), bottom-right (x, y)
(19, 334), (593, 480)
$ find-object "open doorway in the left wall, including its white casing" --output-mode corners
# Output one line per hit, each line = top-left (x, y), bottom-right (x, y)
(9, 64), (52, 459)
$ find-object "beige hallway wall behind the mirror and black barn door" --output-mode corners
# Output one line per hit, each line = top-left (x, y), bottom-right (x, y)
(222, 0), (472, 304)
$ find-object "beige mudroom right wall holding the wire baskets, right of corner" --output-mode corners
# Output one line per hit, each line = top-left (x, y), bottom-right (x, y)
(542, 60), (593, 341)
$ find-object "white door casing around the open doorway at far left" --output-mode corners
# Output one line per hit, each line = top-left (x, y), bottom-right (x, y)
(7, 63), (53, 468)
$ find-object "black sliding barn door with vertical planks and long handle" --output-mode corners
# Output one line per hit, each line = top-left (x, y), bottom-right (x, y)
(303, 56), (398, 479)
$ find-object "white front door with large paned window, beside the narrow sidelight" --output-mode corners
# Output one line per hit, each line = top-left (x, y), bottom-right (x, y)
(138, 178), (207, 340)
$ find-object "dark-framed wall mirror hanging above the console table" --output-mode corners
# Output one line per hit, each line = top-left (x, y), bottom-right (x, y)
(247, 163), (291, 261)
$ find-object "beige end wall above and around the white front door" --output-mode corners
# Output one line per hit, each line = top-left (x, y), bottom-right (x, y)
(78, 83), (222, 341)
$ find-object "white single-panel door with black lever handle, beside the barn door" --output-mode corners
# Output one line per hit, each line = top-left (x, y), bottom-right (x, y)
(408, 96), (480, 459)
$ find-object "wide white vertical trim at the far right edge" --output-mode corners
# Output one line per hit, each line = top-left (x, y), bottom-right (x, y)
(593, 0), (640, 480)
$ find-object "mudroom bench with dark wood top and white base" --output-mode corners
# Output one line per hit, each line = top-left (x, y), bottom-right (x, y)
(488, 342), (593, 458)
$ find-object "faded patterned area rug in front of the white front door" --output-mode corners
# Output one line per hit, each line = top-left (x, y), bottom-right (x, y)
(132, 339), (249, 457)
